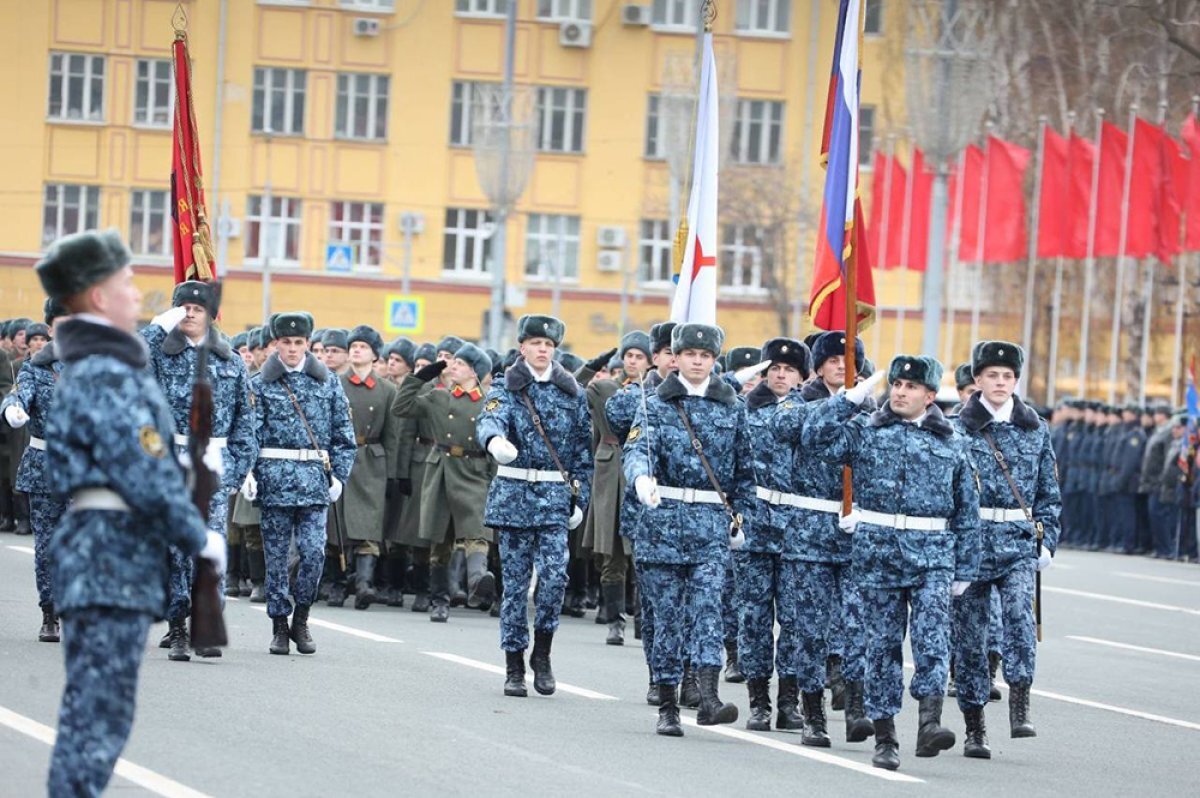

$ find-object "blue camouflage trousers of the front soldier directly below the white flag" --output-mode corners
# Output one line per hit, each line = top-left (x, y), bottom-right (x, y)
(642, 559), (725, 684)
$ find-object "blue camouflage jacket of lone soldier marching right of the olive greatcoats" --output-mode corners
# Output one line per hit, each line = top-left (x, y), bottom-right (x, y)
(475, 359), (593, 529)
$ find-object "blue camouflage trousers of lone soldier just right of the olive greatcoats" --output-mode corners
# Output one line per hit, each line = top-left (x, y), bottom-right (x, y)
(496, 524), (569, 652)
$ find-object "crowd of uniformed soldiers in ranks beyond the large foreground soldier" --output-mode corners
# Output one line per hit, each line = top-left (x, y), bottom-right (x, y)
(0, 234), (1196, 792)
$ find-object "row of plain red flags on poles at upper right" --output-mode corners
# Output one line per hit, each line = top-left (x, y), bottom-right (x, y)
(866, 115), (1200, 271)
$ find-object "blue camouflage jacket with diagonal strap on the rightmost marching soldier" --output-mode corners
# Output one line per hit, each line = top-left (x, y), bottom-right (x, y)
(954, 394), (1062, 580)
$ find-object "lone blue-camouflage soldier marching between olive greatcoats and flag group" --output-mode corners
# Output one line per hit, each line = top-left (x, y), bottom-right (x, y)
(475, 316), (592, 697)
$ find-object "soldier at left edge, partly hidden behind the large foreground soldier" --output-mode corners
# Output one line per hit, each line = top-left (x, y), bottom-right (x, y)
(0, 299), (66, 643)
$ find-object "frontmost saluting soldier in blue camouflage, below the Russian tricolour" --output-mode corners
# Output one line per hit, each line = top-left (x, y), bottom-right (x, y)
(803, 355), (979, 770)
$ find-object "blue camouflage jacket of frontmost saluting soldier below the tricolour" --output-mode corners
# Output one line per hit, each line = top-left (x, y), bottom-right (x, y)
(803, 396), (979, 588)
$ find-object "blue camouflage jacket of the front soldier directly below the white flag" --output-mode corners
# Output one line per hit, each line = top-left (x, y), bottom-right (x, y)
(624, 374), (756, 564)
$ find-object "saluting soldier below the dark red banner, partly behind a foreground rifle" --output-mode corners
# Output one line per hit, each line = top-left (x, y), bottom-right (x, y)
(140, 281), (258, 661)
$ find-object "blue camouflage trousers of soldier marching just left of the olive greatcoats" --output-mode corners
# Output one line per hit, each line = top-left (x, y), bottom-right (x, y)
(262, 504), (329, 618)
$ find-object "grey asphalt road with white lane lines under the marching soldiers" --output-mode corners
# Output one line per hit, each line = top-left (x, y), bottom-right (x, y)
(0, 534), (1200, 798)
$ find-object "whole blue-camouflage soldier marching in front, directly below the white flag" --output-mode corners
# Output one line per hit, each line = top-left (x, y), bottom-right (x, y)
(624, 324), (755, 737)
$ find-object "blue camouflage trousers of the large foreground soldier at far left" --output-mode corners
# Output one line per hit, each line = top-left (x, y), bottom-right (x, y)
(47, 607), (150, 798)
